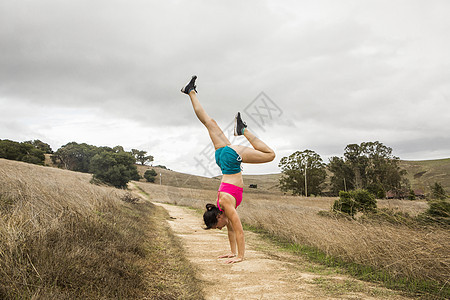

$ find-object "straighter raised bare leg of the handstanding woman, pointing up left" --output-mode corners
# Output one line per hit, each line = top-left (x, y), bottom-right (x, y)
(189, 90), (231, 150)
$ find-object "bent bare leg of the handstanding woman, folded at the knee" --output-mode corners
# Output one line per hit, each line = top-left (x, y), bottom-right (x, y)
(231, 128), (275, 164)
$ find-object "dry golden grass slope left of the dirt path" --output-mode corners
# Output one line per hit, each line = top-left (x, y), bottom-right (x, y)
(0, 159), (202, 299)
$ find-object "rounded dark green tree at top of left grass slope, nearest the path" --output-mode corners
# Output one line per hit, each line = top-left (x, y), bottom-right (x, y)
(89, 151), (139, 188)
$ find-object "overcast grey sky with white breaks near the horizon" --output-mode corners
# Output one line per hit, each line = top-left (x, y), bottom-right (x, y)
(0, 0), (450, 175)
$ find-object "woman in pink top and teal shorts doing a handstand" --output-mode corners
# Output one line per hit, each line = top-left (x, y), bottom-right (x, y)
(181, 76), (275, 264)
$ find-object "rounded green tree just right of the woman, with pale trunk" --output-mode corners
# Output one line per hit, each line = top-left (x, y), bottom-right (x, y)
(278, 150), (326, 196)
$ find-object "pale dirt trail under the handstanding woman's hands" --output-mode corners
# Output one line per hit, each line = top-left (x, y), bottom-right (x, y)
(149, 203), (412, 299)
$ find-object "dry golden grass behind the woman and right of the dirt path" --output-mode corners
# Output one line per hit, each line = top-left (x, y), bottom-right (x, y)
(139, 183), (450, 296)
